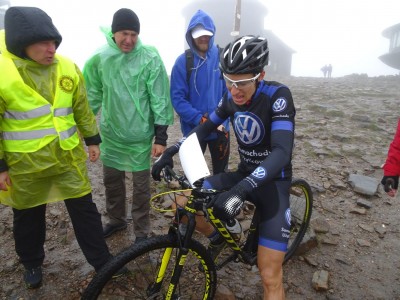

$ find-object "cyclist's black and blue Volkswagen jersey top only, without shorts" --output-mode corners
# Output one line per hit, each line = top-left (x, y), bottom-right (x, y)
(210, 81), (296, 185)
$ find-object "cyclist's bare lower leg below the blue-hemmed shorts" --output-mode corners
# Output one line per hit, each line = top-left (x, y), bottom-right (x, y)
(257, 245), (285, 300)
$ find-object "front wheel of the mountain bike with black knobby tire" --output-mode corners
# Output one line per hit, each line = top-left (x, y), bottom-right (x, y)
(82, 233), (217, 300)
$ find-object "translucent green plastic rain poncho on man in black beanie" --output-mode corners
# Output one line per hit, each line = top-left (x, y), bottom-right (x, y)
(83, 28), (173, 172)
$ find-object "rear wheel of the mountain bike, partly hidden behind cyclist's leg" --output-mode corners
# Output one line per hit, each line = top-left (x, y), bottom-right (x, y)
(284, 178), (313, 263)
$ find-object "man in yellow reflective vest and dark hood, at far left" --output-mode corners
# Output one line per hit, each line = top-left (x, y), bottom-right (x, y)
(0, 6), (115, 288)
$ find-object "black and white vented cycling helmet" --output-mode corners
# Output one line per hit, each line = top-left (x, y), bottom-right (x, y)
(219, 35), (269, 74)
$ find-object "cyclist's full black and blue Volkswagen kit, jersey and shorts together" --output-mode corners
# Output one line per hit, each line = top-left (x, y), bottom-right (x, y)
(194, 81), (296, 251)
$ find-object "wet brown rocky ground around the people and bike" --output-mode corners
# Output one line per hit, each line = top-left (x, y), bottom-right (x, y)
(0, 75), (400, 299)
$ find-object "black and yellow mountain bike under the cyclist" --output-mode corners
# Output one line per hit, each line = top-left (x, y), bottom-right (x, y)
(82, 167), (313, 299)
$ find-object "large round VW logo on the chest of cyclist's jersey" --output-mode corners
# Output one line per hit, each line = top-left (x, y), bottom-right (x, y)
(233, 112), (265, 146)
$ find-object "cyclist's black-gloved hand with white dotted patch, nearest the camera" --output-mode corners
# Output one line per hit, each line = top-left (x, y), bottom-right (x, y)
(212, 183), (247, 220)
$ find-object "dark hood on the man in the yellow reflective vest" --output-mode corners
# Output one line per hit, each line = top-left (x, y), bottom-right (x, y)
(4, 6), (62, 58)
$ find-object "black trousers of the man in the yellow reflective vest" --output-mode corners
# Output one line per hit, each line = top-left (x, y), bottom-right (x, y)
(13, 193), (111, 271)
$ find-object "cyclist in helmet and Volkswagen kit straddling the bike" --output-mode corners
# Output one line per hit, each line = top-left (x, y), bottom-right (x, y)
(152, 36), (295, 299)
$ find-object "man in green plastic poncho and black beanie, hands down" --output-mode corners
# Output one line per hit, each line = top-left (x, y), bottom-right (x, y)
(83, 8), (173, 242)
